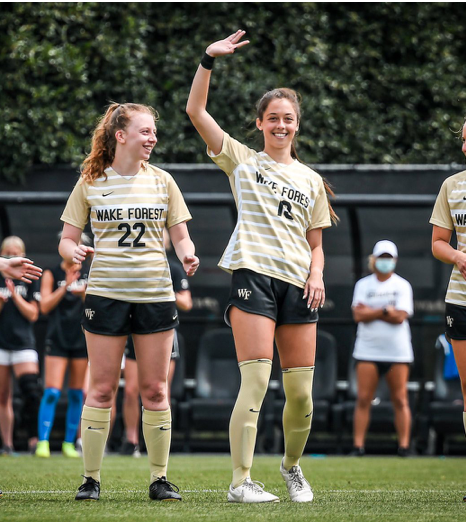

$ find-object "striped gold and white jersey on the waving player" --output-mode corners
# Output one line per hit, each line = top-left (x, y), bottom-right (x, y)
(207, 133), (331, 288)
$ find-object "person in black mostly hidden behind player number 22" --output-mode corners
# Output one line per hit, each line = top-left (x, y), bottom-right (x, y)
(120, 229), (193, 458)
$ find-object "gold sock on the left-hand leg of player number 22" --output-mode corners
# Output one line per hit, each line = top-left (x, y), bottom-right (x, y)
(81, 406), (112, 482)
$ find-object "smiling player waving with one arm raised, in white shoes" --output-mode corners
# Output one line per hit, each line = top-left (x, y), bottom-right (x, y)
(186, 31), (331, 502)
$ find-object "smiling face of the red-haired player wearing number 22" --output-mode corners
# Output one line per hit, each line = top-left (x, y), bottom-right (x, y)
(115, 111), (157, 161)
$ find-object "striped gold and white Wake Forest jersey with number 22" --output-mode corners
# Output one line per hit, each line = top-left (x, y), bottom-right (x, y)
(61, 165), (191, 303)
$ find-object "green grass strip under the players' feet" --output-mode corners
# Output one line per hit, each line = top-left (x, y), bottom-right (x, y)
(0, 455), (466, 522)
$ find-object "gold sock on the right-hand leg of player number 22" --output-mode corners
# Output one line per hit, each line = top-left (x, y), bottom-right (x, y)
(142, 408), (172, 484)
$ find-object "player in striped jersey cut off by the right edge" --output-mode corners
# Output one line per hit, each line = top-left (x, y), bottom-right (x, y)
(430, 118), (466, 502)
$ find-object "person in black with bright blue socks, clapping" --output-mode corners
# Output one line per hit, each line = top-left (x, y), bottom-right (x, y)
(36, 234), (91, 458)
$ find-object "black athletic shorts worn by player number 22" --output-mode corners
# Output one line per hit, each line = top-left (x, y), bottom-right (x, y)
(81, 294), (179, 335)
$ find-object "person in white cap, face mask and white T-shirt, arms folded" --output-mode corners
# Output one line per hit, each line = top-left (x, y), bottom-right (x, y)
(350, 240), (414, 457)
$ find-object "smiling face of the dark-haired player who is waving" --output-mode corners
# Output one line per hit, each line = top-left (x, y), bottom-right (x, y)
(256, 98), (299, 153)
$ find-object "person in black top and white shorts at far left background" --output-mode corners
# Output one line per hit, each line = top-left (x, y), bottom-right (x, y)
(0, 236), (42, 455)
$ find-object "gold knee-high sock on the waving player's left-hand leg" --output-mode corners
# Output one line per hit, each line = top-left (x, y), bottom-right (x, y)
(230, 359), (272, 488)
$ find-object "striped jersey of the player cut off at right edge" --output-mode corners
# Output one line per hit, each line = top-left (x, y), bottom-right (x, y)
(430, 170), (466, 306)
